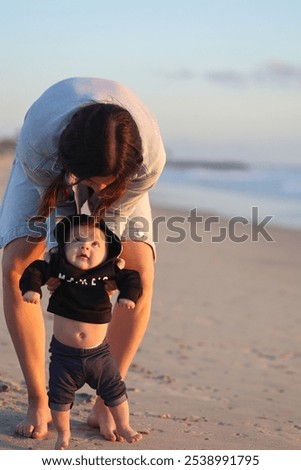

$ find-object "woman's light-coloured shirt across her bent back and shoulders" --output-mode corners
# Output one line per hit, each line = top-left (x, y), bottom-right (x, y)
(17, 78), (166, 239)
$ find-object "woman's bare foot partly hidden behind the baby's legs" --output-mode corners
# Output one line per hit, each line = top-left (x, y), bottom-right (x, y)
(87, 398), (124, 442)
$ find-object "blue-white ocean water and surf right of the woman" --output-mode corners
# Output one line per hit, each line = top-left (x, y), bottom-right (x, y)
(150, 161), (301, 229)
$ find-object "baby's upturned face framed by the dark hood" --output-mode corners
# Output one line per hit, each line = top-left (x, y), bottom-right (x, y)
(65, 225), (107, 270)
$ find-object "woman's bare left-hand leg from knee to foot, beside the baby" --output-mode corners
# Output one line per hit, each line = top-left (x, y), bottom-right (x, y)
(2, 238), (50, 439)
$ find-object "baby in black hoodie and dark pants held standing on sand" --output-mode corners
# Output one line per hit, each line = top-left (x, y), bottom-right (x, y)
(20, 214), (142, 449)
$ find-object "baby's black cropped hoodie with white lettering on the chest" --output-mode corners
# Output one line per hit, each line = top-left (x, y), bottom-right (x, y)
(20, 216), (142, 323)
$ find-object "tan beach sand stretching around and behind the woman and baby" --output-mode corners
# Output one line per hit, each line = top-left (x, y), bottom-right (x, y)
(0, 152), (301, 450)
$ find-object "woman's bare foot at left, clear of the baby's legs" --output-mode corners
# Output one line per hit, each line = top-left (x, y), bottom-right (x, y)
(16, 401), (51, 439)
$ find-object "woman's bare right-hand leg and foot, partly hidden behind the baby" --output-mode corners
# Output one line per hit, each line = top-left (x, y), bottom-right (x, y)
(88, 240), (154, 440)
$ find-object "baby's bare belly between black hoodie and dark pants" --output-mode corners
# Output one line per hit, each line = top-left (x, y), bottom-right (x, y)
(53, 315), (107, 348)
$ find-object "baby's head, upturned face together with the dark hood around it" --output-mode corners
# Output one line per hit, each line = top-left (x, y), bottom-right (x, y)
(55, 214), (120, 270)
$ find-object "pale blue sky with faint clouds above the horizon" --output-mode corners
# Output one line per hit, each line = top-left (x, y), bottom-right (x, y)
(0, 0), (301, 165)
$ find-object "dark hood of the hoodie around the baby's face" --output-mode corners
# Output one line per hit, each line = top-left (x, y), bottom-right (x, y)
(53, 214), (122, 263)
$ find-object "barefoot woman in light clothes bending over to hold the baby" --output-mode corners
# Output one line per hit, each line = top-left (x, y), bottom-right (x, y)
(0, 78), (165, 441)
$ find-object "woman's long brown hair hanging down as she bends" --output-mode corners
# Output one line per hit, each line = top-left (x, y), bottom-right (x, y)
(38, 103), (143, 217)
